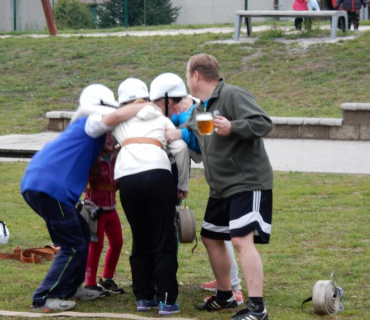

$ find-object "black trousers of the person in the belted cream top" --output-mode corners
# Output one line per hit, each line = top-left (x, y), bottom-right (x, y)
(118, 169), (178, 304)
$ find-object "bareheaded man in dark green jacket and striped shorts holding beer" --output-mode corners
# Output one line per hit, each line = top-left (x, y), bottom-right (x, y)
(186, 54), (273, 320)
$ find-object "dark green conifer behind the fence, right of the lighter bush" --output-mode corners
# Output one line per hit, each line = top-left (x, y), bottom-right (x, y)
(97, 0), (181, 28)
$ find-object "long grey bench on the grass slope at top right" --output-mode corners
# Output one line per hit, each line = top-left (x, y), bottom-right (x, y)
(234, 10), (348, 41)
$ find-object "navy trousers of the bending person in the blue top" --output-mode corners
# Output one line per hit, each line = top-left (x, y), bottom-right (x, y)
(23, 191), (90, 306)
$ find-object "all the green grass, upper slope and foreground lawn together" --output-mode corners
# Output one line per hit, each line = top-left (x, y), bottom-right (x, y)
(0, 22), (370, 320)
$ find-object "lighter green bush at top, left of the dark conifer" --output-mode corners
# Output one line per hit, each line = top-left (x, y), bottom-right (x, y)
(54, 0), (95, 29)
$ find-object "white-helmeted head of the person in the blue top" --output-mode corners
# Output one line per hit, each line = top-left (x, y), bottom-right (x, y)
(71, 84), (118, 123)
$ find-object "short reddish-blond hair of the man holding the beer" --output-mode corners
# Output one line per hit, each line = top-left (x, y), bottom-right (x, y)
(188, 53), (220, 82)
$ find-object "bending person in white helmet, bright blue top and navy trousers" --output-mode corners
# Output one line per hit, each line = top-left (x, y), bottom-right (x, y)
(21, 84), (147, 312)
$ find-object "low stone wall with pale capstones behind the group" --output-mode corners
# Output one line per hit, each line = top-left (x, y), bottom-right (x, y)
(46, 103), (370, 141)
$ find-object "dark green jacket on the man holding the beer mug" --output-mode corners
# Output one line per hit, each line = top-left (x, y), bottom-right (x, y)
(185, 79), (273, 199)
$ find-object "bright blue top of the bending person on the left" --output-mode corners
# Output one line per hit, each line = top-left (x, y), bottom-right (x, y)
(21, 117), (106, 206)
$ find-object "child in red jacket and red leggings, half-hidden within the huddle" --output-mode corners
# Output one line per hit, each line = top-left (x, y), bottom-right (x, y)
(85, 133), (124, 293)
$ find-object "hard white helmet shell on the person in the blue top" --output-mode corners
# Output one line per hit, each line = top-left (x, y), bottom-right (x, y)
(80, 84), (118, 108)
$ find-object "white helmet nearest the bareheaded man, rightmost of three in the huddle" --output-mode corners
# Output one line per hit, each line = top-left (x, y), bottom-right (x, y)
(149, 72), (188, 101)
